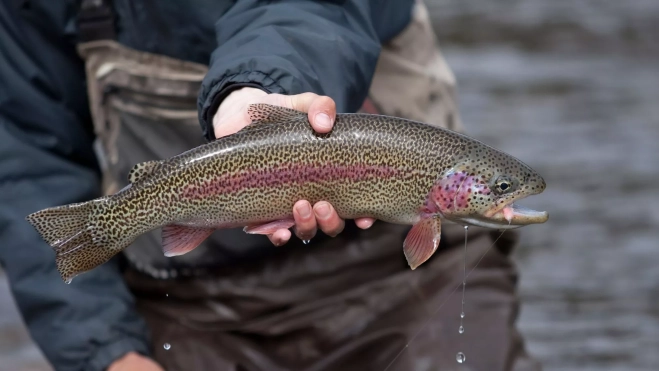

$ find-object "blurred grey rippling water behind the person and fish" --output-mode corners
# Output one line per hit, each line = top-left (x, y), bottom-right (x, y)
(0, 0), (659, 371)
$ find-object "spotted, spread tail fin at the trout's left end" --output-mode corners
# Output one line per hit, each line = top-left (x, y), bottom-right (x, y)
(26, 201), (123, 283)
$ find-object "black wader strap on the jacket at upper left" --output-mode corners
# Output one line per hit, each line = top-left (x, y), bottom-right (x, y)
(78, 0), (117, 43)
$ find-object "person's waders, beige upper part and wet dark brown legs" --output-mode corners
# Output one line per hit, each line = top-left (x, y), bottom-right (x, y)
(79, 3), (540, 371)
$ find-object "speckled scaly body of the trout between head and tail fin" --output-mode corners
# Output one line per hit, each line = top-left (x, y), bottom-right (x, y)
(113, 114), (459, 226)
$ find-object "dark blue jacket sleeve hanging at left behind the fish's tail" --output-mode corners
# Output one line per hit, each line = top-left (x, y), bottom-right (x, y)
(0, 2), (148, 371)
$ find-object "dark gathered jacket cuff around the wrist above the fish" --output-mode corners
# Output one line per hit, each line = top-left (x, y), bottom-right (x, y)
(199, 71), (287, 141)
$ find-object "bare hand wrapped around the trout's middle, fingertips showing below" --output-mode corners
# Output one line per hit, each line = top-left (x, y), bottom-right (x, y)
(213, 87), (375, 246)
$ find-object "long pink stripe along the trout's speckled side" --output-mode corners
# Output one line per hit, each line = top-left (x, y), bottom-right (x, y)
(181, 164), (401, 199)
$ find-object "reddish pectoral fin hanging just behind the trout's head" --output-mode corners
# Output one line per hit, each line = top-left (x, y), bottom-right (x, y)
(403, 217), (442, 270)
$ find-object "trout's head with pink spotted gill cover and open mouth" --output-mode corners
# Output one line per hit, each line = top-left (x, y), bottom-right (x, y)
(431, 142), (548, 229)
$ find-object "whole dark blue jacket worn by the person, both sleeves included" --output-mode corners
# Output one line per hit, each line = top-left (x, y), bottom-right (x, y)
(0, 0), (413, 371)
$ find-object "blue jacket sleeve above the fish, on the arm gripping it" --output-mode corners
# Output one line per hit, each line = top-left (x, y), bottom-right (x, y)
(199, 0), (414, 139)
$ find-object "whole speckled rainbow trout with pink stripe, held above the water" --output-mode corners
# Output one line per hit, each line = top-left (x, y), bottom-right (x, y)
(27, 104), (547, 281)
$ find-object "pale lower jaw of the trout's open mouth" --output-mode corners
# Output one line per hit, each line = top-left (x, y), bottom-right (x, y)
(462, 202), (549, 229)
